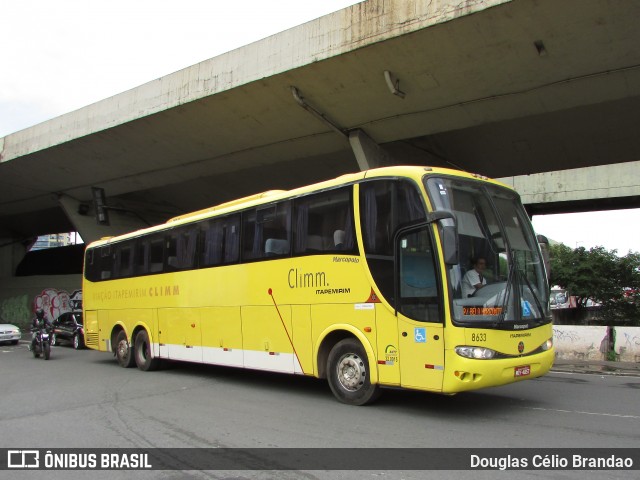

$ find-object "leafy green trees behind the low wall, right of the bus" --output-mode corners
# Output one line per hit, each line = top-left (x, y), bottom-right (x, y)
(550, 244), (640, 325)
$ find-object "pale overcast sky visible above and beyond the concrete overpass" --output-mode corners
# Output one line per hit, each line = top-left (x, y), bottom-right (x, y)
(0, 0), (640, 255)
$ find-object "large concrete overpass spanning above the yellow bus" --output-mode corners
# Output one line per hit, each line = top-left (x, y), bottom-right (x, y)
(0, 0), (640, 316)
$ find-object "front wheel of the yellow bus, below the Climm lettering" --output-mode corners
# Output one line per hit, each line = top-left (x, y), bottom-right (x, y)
(327, 338), (380, 405)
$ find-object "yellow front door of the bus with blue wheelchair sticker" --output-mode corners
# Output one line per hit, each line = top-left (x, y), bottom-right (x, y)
(395, 226), (444, 391)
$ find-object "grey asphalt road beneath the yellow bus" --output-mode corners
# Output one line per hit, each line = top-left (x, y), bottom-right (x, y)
(0, 343), (640, 480)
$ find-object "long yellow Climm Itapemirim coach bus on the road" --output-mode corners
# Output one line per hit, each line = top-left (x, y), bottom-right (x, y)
(83, 166), (554, 405)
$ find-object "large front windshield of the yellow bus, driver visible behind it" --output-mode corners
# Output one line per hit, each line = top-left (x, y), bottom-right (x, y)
(426, 177), (550, 330)
